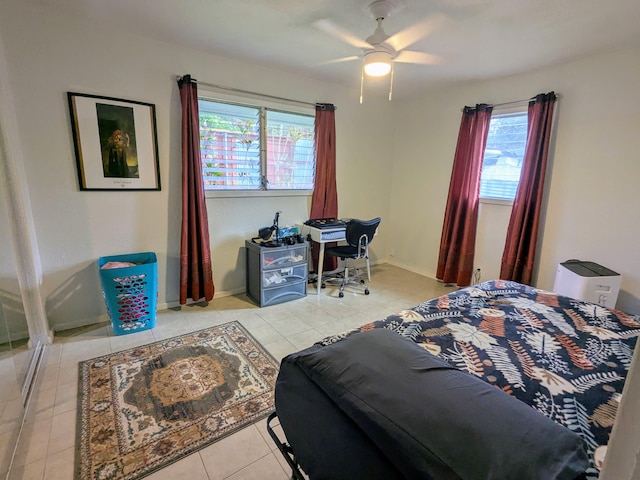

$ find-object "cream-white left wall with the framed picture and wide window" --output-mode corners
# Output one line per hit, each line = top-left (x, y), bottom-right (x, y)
(0, 0), (392, 330)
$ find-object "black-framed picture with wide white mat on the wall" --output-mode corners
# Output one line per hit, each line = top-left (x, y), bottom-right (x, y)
(67, 92), (160, 190)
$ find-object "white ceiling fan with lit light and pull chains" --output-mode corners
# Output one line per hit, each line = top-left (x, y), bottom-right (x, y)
(314, 0), (445, 103)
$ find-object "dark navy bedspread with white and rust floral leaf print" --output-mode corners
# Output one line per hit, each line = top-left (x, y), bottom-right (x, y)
(322, 280), (640, 479)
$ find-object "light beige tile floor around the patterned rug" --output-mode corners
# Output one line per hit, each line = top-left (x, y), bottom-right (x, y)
(8, 264), (453, 480)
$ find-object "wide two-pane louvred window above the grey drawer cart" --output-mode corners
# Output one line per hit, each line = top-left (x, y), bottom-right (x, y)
(198, 98), (315, 191)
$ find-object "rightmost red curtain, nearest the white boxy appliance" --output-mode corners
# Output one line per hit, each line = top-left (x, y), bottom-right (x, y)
(500, 92), (556, 285)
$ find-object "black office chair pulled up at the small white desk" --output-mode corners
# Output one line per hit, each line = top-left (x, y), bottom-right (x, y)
(322, 217), (381, 298)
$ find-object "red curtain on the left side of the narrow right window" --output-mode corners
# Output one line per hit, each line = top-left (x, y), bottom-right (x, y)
(436, 104), (493, 287)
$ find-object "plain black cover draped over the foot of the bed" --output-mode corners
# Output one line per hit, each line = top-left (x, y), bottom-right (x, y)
(276, 329), (589, 480)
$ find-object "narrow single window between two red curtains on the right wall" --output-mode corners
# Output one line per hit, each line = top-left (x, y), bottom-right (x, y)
(480, 112), (527, 201)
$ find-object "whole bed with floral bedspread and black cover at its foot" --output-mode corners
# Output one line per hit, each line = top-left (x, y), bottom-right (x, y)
(269, 280), (640, 480)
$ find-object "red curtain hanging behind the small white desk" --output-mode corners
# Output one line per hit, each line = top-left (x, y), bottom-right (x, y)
(309, 103), (338, 272)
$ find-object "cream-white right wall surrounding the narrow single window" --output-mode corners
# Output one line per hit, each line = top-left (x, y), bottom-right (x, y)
(389, 48), (640, 313)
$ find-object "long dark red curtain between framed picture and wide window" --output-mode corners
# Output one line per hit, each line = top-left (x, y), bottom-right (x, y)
(178, 75), (215, 305)
